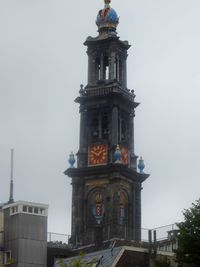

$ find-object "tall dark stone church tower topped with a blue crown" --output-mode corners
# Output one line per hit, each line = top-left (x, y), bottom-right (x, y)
(65, 0), (148, 245)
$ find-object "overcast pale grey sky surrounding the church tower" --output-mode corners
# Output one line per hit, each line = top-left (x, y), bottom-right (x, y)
(0, 0), (200, 233)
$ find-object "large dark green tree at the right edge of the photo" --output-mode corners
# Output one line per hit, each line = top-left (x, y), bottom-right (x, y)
(176, 199), (200, 267)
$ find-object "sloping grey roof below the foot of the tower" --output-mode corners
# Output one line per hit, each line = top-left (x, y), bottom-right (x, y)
(54, 247), (123, 267)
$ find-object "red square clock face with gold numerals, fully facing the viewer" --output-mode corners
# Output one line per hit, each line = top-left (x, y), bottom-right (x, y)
(88, 144), (108, 165)
